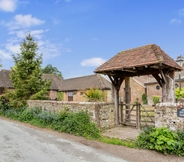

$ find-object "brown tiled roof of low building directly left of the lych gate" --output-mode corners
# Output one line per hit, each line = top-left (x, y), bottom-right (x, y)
(60, 74), (111, 91)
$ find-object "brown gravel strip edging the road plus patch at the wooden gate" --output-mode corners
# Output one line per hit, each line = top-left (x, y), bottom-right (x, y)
(1, 117), (184, 162)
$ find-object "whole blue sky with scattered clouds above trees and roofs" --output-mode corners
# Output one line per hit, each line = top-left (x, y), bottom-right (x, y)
(0, 0), (184, 79)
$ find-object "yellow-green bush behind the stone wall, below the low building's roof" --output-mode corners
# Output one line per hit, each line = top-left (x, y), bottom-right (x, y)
(84, 88), (105, 102)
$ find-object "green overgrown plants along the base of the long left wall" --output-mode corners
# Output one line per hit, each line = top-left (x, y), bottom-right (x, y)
(0, 98), (101, 139)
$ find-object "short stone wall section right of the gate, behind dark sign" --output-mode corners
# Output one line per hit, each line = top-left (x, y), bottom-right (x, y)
(155, 103), (184, 131)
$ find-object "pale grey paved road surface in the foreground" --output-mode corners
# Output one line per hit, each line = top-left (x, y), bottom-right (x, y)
(0, 119), (126, 162)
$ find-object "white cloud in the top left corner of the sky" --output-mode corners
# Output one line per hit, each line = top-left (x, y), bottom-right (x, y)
(0, 0), (17, 12)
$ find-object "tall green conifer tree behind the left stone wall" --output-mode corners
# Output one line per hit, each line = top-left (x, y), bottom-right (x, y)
(8, 34), (51, 107)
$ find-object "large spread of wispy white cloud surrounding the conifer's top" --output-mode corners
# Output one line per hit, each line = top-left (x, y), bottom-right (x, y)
(0, 14), (71, 59)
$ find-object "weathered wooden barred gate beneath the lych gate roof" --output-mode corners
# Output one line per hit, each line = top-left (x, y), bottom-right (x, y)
(119, 103), (155, 129)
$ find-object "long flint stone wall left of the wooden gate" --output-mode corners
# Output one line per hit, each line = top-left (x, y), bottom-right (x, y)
(27, 100), (114, 129)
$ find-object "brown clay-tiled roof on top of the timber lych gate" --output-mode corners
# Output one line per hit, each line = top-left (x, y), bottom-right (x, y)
(95, 44), (181, 72)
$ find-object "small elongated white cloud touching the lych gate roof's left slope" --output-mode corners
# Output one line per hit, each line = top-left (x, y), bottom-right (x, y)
(81, 58), (106, 66)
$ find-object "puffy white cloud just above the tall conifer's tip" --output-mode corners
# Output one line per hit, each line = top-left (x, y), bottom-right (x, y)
(6, 14), (45, 30)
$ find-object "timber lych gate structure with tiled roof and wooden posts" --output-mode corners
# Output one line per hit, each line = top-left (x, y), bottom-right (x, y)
(94, 44), (182, 125)
